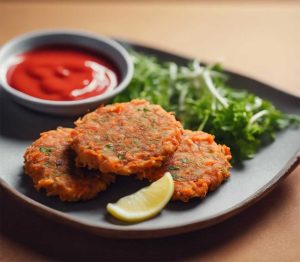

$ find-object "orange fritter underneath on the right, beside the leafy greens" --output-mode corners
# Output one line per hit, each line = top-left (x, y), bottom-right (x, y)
(138, 130), (231, 202)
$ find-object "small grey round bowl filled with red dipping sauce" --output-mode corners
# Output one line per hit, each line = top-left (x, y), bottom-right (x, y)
(0, 29), (134, 117)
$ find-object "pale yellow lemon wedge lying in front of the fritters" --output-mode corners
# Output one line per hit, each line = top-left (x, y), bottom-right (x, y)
(106, 172), (174, 222)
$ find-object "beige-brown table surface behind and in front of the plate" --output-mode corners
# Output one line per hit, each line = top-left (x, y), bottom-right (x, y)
(0, 1), (300, 261)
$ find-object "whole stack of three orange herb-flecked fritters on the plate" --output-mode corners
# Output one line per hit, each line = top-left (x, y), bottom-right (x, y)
(24, 100), (231, 202)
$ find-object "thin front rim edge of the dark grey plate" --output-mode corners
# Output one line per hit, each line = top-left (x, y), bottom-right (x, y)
(0, 152), (300, 239)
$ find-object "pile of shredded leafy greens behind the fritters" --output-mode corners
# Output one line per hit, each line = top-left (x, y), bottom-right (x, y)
(114, 52), (300, 162)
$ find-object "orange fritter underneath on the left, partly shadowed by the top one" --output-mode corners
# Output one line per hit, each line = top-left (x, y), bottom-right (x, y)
(24, 128), (115, 201)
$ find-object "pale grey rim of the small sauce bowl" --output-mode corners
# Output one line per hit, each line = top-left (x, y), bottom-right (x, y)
(0, 29), (134, 107)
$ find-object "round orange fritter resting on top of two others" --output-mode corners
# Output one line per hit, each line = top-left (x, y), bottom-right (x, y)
(72, 100), (182, 175)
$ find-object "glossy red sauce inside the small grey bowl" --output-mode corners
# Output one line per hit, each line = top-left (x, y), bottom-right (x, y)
(7, 46), (118, 101)
